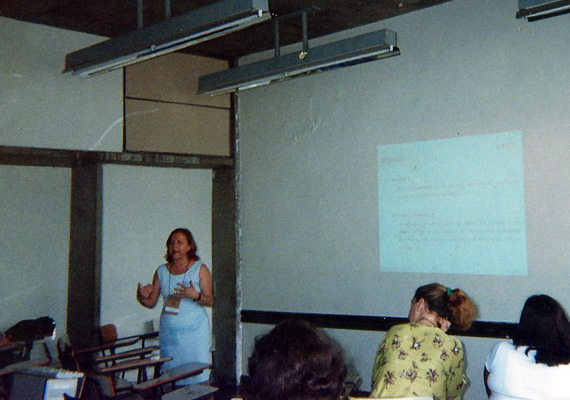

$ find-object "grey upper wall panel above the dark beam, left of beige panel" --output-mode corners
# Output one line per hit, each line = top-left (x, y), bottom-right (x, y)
(0, 17), (123, 151)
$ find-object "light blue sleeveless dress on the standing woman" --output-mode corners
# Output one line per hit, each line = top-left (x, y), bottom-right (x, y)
(157, 261), (210, 385)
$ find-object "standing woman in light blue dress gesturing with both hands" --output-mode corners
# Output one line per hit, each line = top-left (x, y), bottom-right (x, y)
(137, 228), (214, 385)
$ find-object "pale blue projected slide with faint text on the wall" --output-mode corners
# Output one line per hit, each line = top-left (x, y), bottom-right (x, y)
(378, 132), (528, 275)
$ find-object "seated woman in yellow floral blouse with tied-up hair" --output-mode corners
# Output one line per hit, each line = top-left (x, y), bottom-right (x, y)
(370, 283), (477, 400)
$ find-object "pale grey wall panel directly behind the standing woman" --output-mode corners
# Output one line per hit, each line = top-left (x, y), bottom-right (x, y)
(101, 165), (212, 336)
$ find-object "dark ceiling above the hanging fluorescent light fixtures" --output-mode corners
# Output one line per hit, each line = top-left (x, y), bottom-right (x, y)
(0, 0), (451, 61)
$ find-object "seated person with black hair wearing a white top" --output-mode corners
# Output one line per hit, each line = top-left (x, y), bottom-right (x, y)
(485, 294), (570, 400)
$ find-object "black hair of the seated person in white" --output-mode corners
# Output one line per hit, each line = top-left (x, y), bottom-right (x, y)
(513, 294), (570, 366)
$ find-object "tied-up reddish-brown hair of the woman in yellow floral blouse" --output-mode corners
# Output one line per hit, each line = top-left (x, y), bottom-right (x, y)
(414, 283), (477, 331)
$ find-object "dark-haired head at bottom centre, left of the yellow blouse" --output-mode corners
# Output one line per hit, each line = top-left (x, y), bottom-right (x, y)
(244, 321), (346, 400)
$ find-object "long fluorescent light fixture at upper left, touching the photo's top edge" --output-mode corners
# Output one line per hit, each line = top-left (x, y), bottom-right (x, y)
(63, 0), (271, 78)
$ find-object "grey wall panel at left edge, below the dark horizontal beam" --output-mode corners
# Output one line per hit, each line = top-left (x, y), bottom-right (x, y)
(0, 165), (71, 333)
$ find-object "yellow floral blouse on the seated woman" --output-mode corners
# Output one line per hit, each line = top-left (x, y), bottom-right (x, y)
(370, 323), (467, 400)
